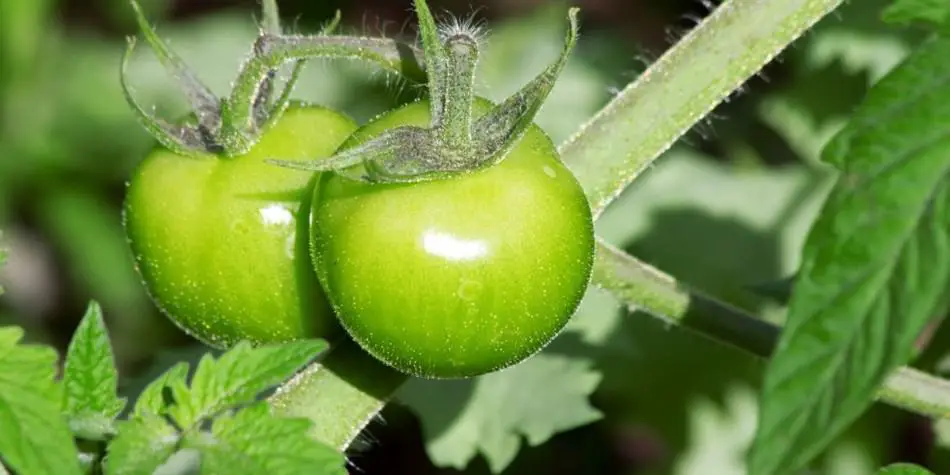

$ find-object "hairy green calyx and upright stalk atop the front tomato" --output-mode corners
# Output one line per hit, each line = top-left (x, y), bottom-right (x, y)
(270, 0), (578, 183)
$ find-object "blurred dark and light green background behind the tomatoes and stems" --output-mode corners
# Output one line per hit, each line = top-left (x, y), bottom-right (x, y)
(0, 0), (950, 475)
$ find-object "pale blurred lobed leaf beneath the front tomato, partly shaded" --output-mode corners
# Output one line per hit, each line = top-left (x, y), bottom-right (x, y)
(399, 352), (601, 473)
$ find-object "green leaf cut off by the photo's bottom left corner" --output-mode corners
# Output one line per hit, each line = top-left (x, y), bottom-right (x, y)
(0, 327), (81, 475)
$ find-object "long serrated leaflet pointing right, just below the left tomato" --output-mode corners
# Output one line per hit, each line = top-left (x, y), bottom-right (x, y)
(168, 340), (327, 429)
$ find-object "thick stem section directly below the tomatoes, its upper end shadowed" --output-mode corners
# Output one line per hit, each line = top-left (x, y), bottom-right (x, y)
(268, 339), (409, 450)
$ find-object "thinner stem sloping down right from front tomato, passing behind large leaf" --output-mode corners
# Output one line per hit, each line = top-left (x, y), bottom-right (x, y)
(593, 239), (950, 417)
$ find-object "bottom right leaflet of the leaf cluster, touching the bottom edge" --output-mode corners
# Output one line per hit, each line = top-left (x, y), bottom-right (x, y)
(185, 403), (347, 475)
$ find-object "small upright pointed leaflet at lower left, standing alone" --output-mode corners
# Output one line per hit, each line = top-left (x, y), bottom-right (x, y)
(63, 302), (125, 440)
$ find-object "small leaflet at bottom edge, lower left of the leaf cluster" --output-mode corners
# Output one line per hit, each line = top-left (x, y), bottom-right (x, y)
(105, 414), (179, 475)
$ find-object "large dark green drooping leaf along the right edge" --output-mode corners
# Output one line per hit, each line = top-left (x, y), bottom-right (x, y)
(749, 38), (950, 475)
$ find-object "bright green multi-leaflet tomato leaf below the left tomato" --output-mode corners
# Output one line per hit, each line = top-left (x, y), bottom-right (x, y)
(108, 340), (336, 475)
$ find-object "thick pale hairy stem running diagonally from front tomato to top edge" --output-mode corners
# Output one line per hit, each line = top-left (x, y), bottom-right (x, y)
(560, 0), (843, 216)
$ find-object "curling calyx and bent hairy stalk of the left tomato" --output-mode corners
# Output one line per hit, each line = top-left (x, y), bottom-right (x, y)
(119, 0), (421, 157)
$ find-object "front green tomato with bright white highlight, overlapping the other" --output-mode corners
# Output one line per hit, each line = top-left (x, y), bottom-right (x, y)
(310, 99), (594, 378)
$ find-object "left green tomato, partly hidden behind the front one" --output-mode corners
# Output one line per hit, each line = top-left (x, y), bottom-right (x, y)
(125, 105), (356, 348)
